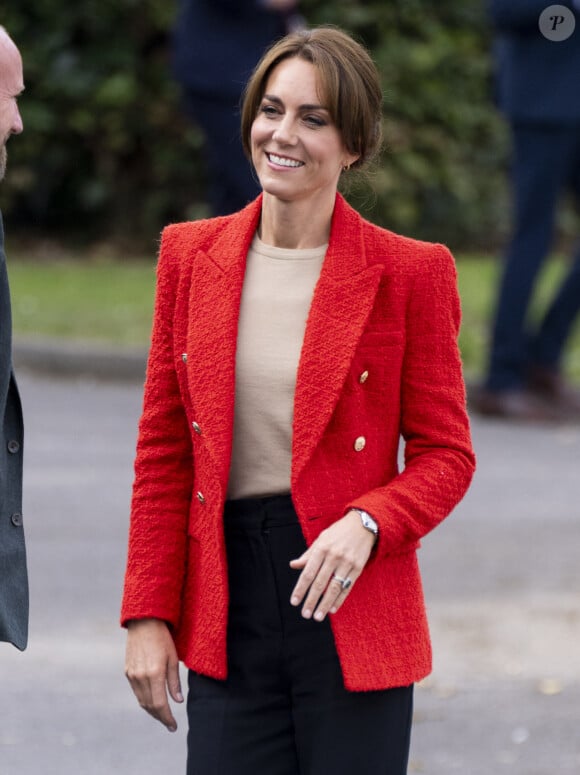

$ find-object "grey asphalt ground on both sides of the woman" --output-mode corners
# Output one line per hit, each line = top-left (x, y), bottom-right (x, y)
(0, 370), (580, 775)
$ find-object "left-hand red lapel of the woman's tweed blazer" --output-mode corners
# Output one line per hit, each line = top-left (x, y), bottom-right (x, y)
(187, 198), (261, 490)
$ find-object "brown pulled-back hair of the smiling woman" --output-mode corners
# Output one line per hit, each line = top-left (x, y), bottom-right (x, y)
(242, 26), (383, 167)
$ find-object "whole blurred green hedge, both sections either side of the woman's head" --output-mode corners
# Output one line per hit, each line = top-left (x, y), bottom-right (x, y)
(0, 0), (507, 247)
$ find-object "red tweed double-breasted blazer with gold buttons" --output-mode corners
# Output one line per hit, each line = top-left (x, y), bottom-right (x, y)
(121, 195), (475, 690)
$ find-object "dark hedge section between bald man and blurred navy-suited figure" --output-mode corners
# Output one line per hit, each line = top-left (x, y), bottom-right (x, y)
(2, 0), (203, 246)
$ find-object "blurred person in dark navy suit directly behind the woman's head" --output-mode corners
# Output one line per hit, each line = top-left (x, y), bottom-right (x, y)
(173, 0), (297, 215)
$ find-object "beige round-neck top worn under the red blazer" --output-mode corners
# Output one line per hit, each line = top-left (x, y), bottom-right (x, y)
(228, 236), (327, 498)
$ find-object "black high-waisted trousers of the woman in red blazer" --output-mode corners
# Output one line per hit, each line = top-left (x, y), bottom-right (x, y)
(187, 495), (413, 775)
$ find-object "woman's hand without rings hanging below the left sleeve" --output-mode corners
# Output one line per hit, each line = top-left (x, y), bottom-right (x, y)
(125, 619), (183, 732)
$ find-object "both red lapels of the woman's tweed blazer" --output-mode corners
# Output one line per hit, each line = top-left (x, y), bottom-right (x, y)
(185, 195), (383, 490)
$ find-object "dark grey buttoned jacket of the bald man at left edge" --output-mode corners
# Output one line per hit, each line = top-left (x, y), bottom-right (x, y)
(0, 214), (28, 649)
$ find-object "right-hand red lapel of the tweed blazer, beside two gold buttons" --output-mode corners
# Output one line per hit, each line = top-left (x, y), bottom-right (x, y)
(292, 195), (383, 486)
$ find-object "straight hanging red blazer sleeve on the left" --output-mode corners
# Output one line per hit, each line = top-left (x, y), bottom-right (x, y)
(121, 227), (193, 626)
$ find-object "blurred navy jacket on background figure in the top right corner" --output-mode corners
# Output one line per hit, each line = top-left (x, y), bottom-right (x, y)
(490, 0), (580, 124)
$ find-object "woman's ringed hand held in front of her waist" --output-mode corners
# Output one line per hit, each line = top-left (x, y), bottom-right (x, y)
(290, 511), (375, 622)
